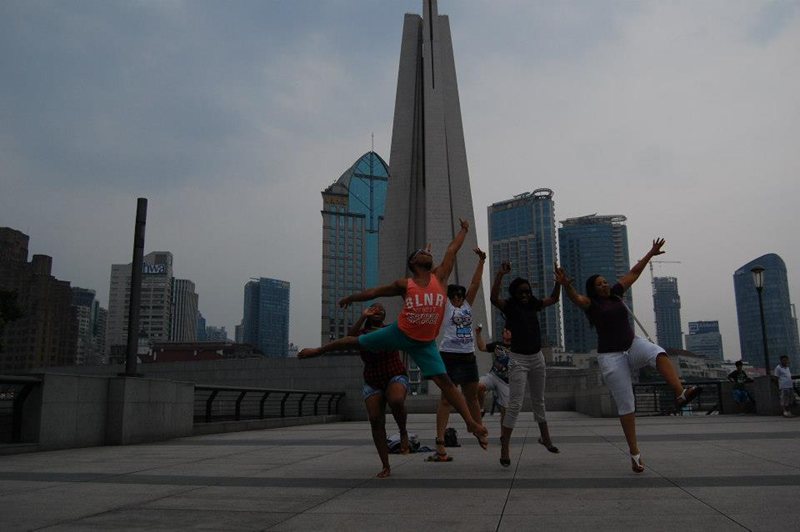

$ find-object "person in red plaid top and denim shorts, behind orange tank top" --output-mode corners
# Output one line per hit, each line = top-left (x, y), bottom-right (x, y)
(304, 303), (410, 478)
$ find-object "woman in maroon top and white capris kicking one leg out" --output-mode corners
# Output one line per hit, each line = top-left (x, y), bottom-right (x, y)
(556, 238), (701, 473)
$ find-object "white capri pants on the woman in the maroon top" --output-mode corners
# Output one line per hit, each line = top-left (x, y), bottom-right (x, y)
(597, 336), (665, 416)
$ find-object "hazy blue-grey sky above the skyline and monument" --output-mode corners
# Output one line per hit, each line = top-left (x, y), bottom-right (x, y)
(0, 0), (800, 359)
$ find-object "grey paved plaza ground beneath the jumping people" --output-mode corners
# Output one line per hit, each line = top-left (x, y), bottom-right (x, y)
(0, 412), (800, 531)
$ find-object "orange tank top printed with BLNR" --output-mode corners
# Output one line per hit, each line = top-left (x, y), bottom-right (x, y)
(397, 275), (447, 342)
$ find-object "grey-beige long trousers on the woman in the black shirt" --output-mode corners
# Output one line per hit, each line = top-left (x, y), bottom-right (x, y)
(503, 351), (547, 429)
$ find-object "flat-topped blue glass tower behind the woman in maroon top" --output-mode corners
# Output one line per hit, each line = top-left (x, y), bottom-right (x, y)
(558, 214), (633, 353)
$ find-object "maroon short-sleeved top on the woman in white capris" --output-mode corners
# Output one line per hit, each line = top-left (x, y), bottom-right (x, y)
(587, 283), (634, 353)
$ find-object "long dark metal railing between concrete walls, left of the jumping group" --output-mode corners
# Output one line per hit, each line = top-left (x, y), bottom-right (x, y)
(194, 384), (344, 423)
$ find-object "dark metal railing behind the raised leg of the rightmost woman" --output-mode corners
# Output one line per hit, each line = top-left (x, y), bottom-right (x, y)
(633, 380), (724, 416)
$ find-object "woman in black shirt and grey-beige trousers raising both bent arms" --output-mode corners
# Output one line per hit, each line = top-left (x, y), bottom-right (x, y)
(491, 262), (561, 467)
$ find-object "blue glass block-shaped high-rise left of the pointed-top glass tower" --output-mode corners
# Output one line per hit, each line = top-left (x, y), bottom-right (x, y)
(241, 277), (289, 357)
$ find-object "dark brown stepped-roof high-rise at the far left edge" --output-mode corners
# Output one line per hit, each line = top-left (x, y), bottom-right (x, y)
(0, 227), (78, 374)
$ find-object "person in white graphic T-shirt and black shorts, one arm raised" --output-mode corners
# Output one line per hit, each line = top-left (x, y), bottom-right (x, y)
(428, 248), (486, 462)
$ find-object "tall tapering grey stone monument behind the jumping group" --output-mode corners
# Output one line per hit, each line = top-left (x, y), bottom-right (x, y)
(380, 0), (488, 332)
